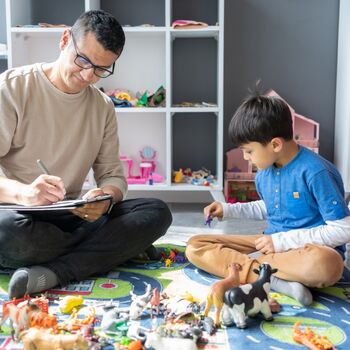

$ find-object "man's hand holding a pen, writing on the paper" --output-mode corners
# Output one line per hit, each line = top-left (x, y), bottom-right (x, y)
(16, 175), (66, 206)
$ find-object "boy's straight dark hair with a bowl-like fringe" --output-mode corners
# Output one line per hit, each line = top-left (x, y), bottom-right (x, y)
(228, 92), (293, 147)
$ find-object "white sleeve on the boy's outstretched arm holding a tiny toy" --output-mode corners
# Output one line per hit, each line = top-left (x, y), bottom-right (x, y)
(221, 200), (267, 220)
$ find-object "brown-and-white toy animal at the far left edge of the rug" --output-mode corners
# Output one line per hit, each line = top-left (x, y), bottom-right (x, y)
(0, 302), (41, 340)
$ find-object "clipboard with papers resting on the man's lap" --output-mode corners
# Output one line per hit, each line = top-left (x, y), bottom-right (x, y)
(0, 194), (113, 212)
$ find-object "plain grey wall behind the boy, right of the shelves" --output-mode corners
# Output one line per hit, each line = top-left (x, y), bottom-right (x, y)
(224, 0), (339, 160)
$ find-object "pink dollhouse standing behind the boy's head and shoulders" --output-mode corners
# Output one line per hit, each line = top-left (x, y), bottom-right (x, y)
(224, 90), (320, 203)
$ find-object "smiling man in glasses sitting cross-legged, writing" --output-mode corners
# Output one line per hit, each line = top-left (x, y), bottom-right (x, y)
(0, 11), (172, 298)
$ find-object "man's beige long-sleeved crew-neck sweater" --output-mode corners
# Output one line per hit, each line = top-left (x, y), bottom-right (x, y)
(0, 64), (127, 198)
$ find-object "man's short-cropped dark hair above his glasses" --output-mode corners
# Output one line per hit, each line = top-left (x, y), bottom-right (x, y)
(71, 10), (125, 56)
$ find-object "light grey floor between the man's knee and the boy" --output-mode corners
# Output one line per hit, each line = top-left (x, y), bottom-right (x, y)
(159, 203), (266, 243)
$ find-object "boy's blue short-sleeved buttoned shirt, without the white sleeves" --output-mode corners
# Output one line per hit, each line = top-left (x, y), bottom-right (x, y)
(256, 146), (350, 253)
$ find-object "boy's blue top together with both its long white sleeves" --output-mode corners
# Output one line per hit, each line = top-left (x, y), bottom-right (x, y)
(224, 146), (350, 255)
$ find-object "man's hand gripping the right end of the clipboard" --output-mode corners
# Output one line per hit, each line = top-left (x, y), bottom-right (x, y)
(72, 188), (111, 222)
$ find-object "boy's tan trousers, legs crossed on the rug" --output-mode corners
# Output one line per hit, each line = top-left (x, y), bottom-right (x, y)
(186, 234), (344, 288)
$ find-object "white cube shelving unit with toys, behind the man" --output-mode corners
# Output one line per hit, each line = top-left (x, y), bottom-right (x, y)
(6, 0), (224, 200)
